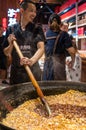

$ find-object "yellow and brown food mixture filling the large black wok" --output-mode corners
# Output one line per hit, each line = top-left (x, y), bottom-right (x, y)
(3, 90), (86, 130)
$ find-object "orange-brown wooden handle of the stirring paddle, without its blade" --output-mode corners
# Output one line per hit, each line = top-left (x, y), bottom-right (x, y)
(13, 41), (44, 98)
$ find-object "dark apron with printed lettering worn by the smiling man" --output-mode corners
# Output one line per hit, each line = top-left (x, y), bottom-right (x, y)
(10, 24), (41, 84)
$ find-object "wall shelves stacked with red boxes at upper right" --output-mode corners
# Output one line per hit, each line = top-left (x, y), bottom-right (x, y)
(59, 0), (86, 50)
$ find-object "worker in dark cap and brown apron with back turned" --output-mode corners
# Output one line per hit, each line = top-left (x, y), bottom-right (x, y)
(43, 13), (75, 80)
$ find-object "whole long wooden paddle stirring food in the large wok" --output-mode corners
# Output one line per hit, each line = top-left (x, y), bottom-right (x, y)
(13, 41), (51, 115)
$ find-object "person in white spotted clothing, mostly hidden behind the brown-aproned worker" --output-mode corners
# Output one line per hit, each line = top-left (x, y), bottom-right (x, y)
(61, 22), (81, 82)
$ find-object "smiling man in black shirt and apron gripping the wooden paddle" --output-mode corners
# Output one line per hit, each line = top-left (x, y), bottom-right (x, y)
(4, 0), (45, 84)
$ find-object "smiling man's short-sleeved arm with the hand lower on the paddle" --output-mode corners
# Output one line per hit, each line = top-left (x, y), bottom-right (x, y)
(20, 23), (45, 66)
